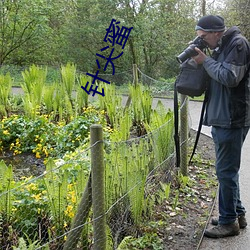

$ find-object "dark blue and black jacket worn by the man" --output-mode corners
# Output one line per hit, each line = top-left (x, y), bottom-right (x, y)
(203, 27), (250, 128)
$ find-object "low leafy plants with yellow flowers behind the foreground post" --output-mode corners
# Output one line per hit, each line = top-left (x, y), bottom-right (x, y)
(0, 106), (104, 158)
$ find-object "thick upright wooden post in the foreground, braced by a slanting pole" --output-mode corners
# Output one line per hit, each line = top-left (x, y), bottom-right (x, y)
(90, 124), (106, 250)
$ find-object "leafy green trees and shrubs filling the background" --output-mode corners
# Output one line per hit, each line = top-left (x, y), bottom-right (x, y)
(0, 0), (250, 83)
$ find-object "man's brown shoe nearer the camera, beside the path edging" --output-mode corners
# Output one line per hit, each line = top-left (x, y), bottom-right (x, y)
(204, 222), (240, 238)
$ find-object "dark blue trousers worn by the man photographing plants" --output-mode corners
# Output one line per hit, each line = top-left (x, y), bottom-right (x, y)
(212, 127), (249, 224)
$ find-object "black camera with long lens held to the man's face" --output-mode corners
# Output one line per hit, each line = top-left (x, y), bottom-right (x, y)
(176, 36), (208, 63)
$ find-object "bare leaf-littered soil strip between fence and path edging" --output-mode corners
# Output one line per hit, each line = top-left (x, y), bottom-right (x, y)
(158, 131), (218, 250)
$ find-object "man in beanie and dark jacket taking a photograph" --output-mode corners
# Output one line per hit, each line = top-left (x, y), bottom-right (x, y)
(193, 15), (250, 238)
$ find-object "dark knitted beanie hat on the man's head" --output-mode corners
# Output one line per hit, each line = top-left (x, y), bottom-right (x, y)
(195, 15), (225, 32)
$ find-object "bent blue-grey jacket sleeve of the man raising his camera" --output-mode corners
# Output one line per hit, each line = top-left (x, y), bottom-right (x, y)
(203, 37), (250, 88)
